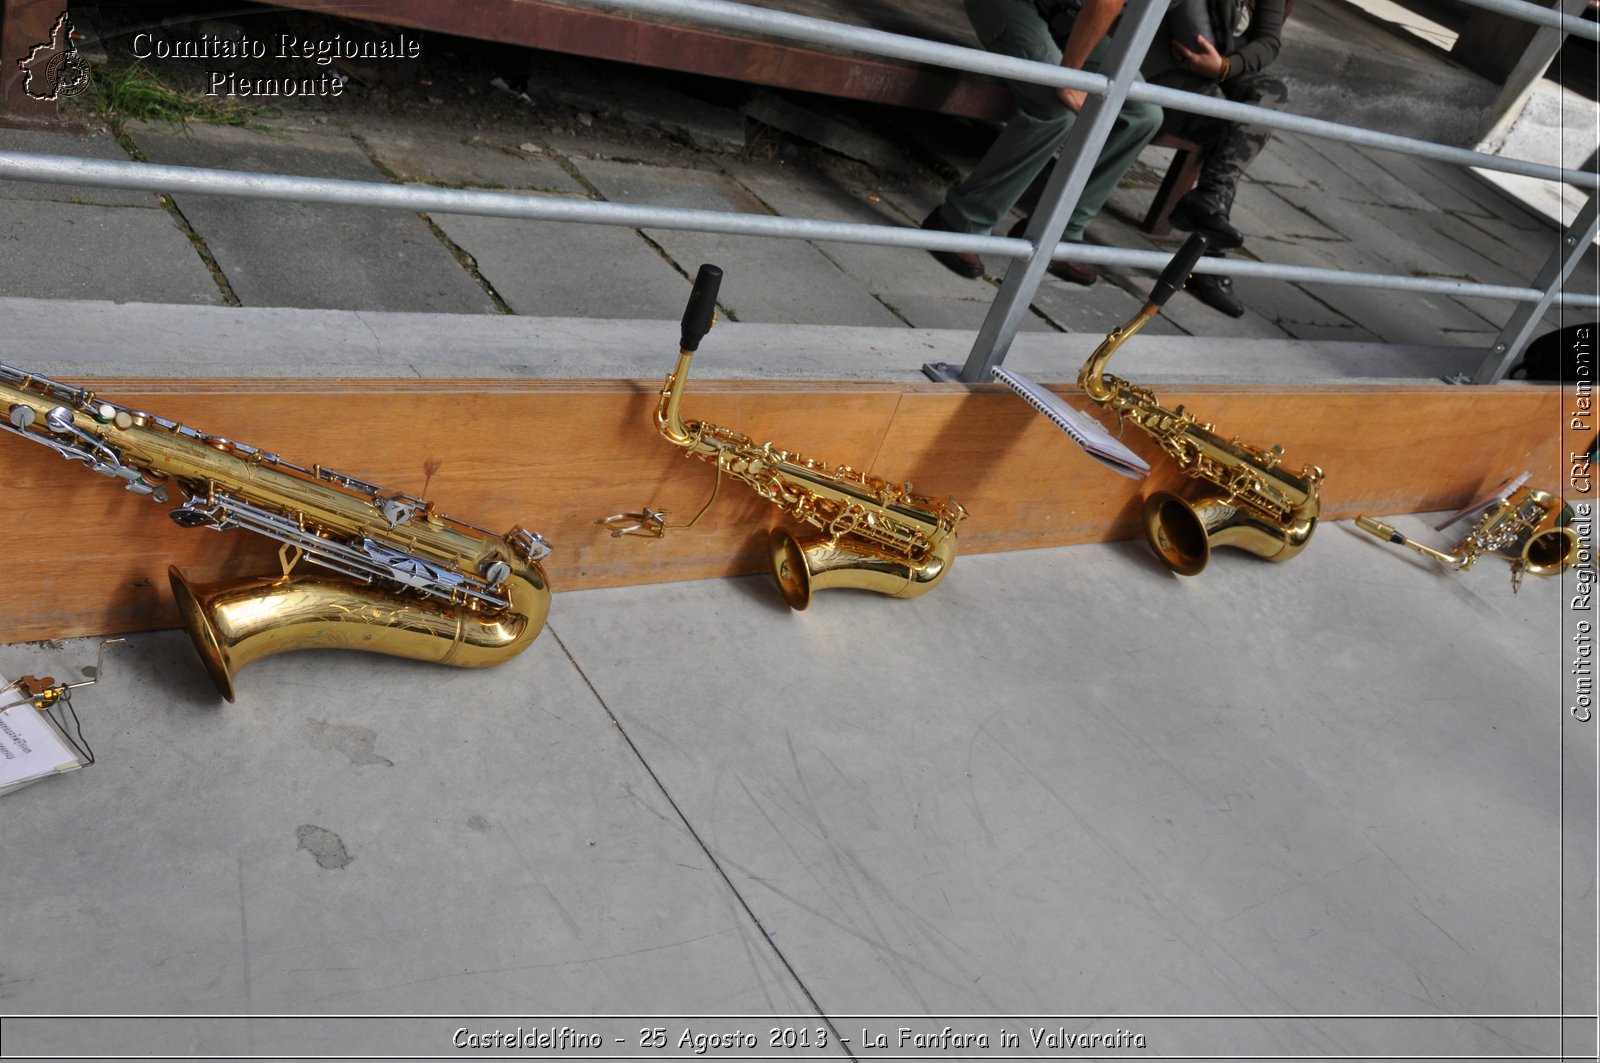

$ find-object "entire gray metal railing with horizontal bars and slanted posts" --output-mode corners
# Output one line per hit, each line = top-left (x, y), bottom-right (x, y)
(0, 0), (1600, 383)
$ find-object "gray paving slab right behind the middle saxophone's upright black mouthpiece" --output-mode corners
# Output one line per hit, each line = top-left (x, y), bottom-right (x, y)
(579, 160), (902, 327)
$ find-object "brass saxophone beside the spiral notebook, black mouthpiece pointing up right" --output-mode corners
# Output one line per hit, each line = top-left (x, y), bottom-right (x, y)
(1078, 232), (1323, 576)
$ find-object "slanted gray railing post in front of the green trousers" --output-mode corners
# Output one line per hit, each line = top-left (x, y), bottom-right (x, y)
(923, 0), (1168, 383)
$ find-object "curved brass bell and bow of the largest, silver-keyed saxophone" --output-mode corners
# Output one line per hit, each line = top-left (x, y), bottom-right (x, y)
(166, 565), (550, 701)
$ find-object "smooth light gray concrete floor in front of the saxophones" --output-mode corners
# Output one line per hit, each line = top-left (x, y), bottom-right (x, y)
(0, 517), (1595, 1058)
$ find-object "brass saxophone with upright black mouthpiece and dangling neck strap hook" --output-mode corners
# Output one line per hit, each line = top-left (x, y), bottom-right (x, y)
(600, 264), (966, 610)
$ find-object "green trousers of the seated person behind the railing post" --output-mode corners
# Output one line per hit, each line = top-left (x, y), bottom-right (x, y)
(941, 0), (1162, 240)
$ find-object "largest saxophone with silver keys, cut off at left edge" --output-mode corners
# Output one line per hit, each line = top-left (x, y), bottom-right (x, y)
(0, 365), (550, 701)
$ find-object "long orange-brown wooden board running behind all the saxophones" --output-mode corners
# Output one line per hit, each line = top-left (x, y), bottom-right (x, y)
(0, 379), (1592, 642)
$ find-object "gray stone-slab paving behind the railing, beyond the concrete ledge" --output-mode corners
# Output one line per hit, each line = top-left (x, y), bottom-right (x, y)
(0, 0), (1580, 361)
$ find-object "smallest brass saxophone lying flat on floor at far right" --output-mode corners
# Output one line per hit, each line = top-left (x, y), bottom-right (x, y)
(1355, 487), (1579, 592)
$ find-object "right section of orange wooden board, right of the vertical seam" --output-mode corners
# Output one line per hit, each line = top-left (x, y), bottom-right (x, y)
(883, 384), (1563, 552)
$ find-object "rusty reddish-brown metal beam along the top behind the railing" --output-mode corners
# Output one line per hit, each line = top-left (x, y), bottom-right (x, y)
(267, 0), (1011, 118)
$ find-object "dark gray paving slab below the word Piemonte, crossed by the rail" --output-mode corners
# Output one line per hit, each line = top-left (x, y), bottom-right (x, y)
(133, 125), (494, 314)
